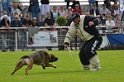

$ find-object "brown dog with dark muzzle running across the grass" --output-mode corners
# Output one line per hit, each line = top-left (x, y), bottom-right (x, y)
(11, 51), (58, 75)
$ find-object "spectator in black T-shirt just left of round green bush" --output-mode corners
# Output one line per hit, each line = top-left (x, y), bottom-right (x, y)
(44, 12), (56, 30)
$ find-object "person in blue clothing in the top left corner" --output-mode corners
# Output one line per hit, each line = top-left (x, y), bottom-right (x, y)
(2, 0), (11, 16)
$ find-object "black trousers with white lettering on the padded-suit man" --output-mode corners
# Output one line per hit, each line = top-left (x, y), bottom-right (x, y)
(79, 37), (102, 65)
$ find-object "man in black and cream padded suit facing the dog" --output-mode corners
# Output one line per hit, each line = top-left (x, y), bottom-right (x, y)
(64, 13), (102, 71)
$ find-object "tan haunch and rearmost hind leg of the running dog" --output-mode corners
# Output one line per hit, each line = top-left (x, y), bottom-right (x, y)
(11, 56), (33, 75)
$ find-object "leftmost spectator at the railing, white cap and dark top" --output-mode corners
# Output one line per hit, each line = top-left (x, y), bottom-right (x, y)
(1, 15), (10, 52)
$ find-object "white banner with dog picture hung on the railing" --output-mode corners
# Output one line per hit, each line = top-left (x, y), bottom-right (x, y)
(28, 31), (58, 47)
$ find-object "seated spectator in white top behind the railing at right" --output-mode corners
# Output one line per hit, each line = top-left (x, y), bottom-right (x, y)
(105, 15), (115, 32)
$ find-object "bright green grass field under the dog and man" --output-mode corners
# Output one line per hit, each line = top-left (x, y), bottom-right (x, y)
(0, 50), (124, 82)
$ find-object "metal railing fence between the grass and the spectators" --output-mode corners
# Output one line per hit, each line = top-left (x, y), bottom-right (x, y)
(0, 26), (123, 50)
